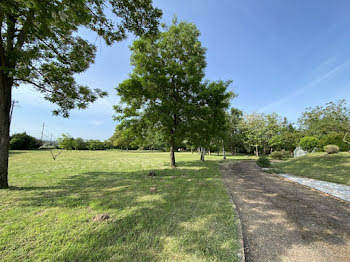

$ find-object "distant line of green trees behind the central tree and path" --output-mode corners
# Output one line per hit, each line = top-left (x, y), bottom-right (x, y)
(108, 100), (350, 156)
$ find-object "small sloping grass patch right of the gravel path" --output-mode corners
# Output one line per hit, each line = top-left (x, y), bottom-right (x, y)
(272, 152), (350, 185)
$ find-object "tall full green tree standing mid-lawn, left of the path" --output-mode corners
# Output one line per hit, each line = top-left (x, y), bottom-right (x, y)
(115, 19), (206, 167)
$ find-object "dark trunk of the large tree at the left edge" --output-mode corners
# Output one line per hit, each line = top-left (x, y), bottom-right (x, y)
(0, 73), (12, 188)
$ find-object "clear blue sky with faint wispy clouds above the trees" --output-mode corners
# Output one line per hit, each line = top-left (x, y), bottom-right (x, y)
(11, 0), (350, 140)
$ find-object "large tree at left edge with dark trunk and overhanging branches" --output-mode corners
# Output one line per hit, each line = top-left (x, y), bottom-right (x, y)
(0, 0), (162, 188)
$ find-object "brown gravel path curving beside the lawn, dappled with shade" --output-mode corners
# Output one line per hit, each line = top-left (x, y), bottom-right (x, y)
(221, 161), (350, 262)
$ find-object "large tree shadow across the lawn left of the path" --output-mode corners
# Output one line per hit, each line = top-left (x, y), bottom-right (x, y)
(6, 161), (238, 261)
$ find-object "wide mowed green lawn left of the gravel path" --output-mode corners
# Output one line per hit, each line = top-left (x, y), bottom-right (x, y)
(0, 151), (243, 261)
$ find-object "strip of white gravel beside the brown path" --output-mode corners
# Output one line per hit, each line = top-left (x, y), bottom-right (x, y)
(278, 174), (350, 202)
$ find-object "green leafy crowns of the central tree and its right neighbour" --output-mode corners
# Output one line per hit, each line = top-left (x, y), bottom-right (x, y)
(115, 20), (232, 165)
